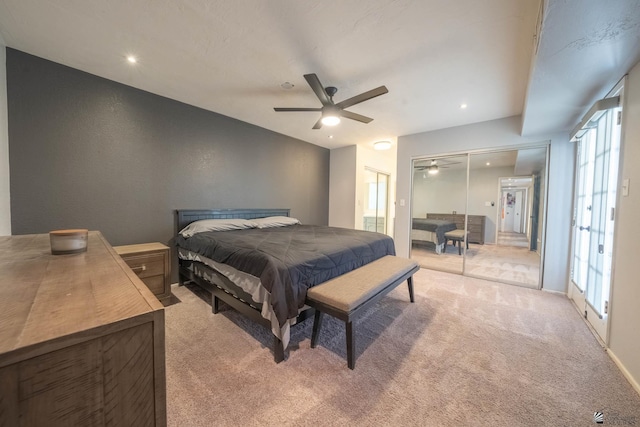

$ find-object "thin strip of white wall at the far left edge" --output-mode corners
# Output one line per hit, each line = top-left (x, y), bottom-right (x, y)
(0, 41), (11, 236)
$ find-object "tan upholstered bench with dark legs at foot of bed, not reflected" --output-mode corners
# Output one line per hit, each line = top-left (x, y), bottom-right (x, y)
(306, 255), (420, 369)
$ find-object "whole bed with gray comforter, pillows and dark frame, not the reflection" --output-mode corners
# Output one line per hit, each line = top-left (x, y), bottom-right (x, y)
(175, 209), (395, 362)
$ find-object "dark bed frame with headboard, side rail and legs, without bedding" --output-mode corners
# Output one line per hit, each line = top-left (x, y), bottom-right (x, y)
(176, 209), (314, 363)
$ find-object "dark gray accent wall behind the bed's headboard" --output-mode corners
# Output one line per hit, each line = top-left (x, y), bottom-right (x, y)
(6, 48), (329, 245)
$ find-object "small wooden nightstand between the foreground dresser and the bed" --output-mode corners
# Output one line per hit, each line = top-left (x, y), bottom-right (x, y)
(113, 243), (171, 305)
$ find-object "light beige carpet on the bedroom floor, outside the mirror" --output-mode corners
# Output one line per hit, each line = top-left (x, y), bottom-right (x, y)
(166, 269), (640, 427)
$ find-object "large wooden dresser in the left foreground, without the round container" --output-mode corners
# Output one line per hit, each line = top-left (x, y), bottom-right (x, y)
(0, 231), (167, 426)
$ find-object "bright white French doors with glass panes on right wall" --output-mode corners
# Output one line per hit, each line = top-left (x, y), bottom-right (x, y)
(569, 95), (621, 342)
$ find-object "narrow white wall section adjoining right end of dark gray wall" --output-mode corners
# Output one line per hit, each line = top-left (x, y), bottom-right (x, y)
(329, 145), (357, 228)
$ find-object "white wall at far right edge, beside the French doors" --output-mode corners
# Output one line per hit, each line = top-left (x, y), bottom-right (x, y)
(609, 64), (640, 393)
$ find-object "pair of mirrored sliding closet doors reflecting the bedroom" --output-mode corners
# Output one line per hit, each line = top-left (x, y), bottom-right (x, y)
(411, 145), (547, 288)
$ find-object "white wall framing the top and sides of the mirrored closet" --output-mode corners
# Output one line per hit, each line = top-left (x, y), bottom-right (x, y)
(395, 116), (574, 292)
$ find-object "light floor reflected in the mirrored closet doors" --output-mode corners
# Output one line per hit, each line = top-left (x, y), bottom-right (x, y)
(411, 242), (540, 288)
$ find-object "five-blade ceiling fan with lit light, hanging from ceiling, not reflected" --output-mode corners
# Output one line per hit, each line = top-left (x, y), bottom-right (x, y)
(274, 74), (389, 129)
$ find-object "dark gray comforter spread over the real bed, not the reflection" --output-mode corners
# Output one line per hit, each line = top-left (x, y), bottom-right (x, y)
(176, 225), (395, 326)
